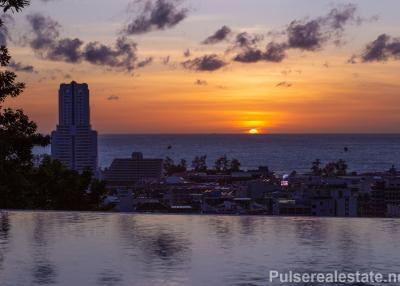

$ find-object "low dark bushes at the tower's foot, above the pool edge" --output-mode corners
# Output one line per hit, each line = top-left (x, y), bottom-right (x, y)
(0, 156), (106, 210)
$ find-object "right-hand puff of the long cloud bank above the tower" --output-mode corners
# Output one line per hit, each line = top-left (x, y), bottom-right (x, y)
(83, 37), (137, 72)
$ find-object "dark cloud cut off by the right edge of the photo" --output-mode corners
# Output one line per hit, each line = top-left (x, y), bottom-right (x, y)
(361, 34), (400, 62)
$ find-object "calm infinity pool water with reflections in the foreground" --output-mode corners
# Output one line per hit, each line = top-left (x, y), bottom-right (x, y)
(0, 212), (400, 286)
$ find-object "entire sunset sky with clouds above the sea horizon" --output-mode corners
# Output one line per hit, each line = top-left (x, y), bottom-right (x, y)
(3, 0), (400, 134)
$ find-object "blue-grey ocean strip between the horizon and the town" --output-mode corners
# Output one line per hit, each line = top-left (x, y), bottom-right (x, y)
(35, 134), (400, 173)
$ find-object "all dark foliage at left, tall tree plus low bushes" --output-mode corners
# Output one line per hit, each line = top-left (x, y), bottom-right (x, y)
(0, 0), (106, 210)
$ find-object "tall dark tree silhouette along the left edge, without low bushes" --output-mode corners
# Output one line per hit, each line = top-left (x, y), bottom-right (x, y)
(0, 0), (49, 208)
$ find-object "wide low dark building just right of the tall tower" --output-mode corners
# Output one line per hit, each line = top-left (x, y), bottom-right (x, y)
(103, 152), (163, 188)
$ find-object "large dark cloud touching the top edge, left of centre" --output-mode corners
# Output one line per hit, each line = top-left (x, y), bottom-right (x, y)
(123, 0), (188, 35)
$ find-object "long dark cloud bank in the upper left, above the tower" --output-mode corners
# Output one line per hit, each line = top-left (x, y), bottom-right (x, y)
(26, 14), (144, 72)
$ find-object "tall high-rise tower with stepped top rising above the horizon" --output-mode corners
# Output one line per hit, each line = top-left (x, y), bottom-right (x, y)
(51, 81), (98, 174)
